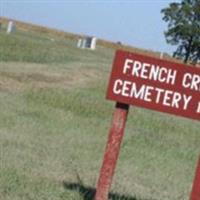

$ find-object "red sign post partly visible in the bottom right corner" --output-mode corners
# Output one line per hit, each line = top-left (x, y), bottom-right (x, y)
(190, 157), (200, 200)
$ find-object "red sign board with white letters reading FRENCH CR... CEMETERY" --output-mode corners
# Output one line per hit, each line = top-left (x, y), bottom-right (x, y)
(107, 50), (200, 120)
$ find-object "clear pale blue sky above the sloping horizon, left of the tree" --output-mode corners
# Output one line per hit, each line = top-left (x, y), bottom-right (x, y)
(0, 0), (180, 54)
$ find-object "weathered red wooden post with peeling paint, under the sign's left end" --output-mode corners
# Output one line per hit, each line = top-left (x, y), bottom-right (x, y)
(95, 102), (129, 200)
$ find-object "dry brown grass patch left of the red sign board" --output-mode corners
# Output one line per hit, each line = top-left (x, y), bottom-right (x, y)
(0, 62), (104, 91)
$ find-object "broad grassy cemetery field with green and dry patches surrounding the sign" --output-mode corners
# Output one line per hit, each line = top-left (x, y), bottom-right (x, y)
(0, 20), (200, 200)
